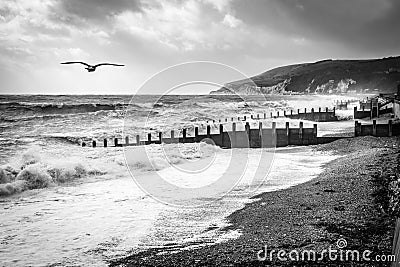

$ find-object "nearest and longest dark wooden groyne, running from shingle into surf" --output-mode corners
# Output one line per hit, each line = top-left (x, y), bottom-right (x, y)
(82, 122), (342, 148)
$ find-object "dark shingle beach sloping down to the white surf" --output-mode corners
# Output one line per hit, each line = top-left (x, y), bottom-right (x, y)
(109, 137), (399, 266)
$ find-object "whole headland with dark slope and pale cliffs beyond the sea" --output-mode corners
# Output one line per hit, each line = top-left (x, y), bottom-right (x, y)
(211, 57), (400, 95)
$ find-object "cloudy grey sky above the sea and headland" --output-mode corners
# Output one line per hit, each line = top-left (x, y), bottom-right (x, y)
(0, 0), (400, 94)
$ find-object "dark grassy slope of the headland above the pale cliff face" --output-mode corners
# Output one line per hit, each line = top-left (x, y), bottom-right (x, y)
(217, 57), (400, 93)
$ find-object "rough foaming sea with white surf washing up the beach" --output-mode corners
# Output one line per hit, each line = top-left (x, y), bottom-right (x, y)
(0, 95), (353, 266)
